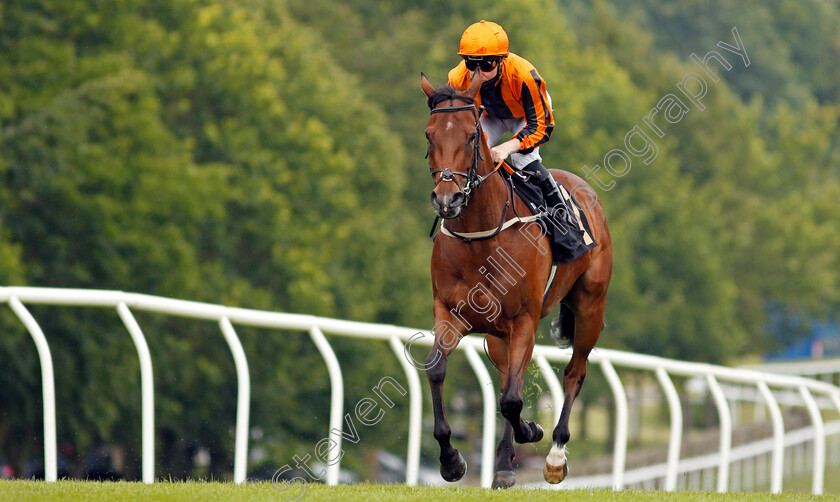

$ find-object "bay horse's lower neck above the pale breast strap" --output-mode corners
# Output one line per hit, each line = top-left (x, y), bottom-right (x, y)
(446, 160), (508, 233)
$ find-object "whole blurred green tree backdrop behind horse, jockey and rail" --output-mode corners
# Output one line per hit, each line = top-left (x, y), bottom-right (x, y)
(0, 0), (840, 479)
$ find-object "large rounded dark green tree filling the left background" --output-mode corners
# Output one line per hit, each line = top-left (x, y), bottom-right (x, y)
(0, 2), (430, 477)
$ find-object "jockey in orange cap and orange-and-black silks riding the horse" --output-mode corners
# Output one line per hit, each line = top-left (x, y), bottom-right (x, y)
(449, 21), (565, 213)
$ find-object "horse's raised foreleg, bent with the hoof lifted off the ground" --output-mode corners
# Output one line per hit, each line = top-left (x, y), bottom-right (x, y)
(499, 315), (543, 443)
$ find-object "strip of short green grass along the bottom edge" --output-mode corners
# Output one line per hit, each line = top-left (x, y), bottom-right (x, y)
(0, 481), (837, 502)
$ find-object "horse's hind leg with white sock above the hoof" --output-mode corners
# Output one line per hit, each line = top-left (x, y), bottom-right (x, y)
(543, 290), (606, 483)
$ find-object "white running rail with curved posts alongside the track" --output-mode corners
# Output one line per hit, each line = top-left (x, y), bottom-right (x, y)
(0, 287), (840, 494)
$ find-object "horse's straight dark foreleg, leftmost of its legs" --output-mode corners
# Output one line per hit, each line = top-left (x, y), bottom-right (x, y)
(425, 300), (467, 482)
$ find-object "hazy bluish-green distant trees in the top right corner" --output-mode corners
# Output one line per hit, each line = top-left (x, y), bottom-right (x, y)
(588, 0), (840, 103)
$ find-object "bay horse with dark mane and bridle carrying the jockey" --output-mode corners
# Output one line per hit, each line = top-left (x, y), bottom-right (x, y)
(420, 74), (612, 488)
